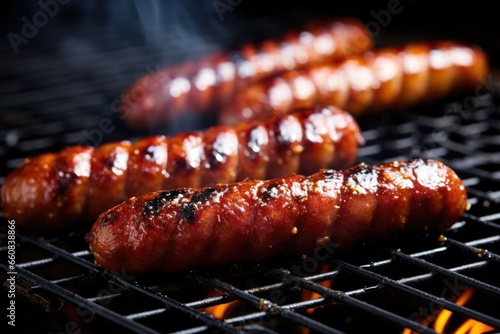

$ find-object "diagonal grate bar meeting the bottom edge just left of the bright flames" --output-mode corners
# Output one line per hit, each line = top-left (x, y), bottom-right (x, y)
(269, 268), (434, 333)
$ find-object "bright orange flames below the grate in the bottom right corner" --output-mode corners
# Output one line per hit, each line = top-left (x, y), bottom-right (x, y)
(402, 288), (493, 334)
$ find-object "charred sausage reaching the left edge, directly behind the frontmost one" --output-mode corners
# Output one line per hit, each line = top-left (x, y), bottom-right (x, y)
(2, 107), (363, 229)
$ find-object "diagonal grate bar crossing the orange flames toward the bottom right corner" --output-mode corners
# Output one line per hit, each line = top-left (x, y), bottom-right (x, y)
(334, 260), (500, 328)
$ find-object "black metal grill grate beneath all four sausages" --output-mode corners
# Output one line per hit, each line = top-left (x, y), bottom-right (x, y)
(0, 3), (500, 333)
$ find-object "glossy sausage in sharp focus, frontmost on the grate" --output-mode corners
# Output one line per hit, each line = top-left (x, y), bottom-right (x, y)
(86, 159), (467, 272)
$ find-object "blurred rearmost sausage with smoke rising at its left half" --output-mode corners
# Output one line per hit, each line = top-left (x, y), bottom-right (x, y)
(119, 18), (373, 129)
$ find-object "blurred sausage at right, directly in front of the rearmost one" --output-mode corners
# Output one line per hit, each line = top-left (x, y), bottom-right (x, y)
(219, 41), (489, 124)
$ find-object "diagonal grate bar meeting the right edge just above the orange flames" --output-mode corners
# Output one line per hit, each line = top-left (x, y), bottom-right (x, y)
(390, 250), (500, 296)
